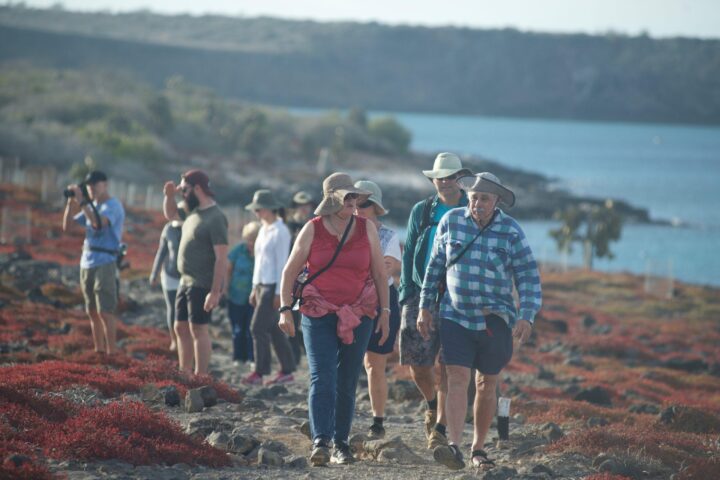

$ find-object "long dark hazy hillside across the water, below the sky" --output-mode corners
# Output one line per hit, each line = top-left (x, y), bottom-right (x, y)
(0, 6), (720, 124)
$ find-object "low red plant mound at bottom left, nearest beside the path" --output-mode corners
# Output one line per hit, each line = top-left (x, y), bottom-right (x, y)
(42, 402), (230, 467)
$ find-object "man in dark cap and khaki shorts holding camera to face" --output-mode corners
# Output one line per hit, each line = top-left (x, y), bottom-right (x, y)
(63, 170), (125, 354)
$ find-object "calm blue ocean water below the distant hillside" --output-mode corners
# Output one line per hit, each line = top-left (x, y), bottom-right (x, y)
(292, 109), (720, 285)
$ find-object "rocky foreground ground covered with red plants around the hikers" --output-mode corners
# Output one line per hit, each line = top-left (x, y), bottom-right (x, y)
(0, 185), (720, 480)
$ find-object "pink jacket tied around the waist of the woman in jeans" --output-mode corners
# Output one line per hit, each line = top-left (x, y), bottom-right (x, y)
(300, 279), (378, 345)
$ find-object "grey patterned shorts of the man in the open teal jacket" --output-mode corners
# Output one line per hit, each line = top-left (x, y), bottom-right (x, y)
(400, 294), (440, 367)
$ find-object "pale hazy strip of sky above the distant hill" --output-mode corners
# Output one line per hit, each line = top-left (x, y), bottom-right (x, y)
(15, 0), (720, 38)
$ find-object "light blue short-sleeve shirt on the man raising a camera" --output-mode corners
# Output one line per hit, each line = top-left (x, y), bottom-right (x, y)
(74, 197), (125, 268)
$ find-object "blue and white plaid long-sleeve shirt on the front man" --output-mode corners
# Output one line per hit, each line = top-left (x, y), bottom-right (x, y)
(420, 208), (542, 330)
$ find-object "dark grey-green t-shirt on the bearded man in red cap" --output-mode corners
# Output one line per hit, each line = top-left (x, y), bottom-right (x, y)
(178, 205), (228, 289)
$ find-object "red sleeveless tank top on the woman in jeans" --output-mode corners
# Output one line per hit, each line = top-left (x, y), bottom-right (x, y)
(307, 216), (370, 305)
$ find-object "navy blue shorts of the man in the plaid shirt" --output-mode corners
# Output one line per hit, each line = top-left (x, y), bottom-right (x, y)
(440, 315), (513, 375)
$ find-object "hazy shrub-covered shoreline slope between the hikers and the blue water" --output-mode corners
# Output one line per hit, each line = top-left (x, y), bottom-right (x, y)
(0, 65), (649, 225)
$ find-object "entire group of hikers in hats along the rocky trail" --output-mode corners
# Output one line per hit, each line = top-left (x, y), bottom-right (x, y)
(63, 153), (541, 469)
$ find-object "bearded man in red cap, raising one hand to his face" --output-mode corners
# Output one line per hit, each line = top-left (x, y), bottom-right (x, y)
(163, 170), (228, 375)
